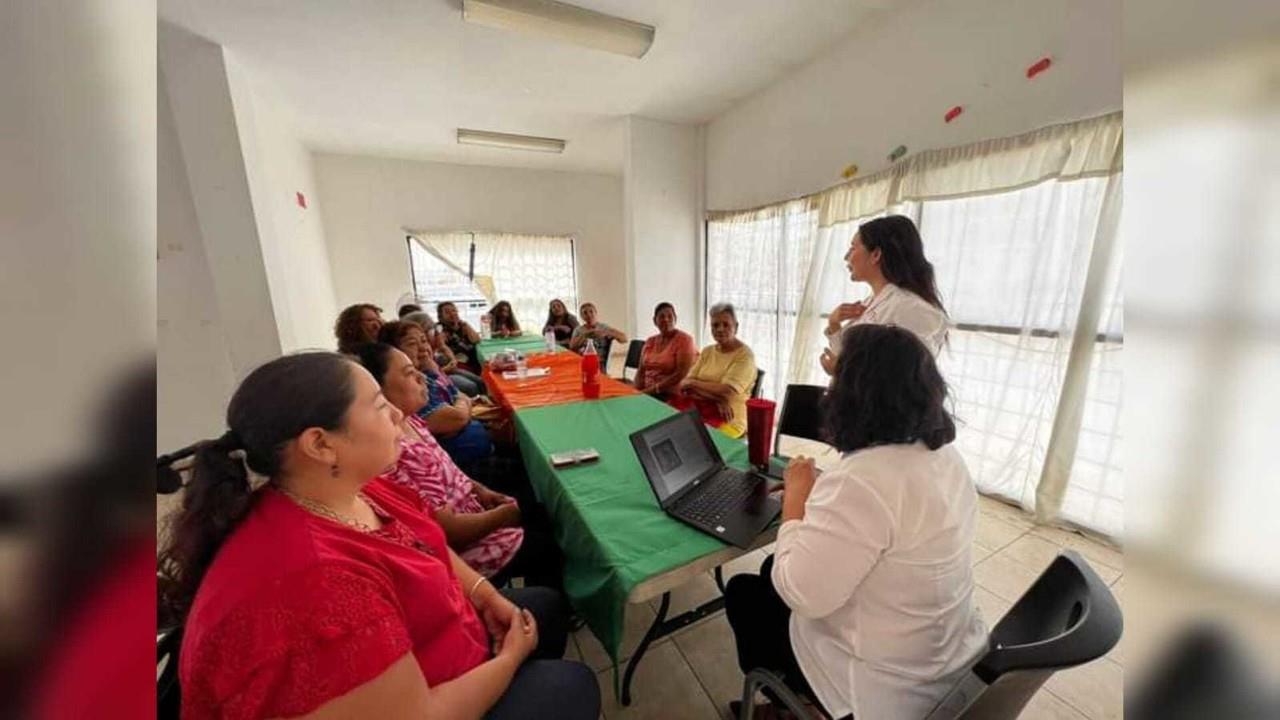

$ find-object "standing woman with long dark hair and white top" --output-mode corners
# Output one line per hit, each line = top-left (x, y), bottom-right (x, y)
(820, 215), (947, 375)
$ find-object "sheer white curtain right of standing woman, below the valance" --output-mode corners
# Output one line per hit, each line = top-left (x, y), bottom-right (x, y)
(922, 176), (1123, 534)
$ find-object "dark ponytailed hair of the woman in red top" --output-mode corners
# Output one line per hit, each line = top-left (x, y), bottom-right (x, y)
(159, 352), (356, 618)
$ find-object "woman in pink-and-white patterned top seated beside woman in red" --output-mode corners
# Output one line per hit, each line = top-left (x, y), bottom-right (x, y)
(356, 343), (562, 588)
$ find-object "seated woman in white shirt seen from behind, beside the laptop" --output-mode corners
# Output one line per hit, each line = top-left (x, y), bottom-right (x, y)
(724, 324), (987, 720)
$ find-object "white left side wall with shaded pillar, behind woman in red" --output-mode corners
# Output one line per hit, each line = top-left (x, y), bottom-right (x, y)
(156, 23), (337, 450)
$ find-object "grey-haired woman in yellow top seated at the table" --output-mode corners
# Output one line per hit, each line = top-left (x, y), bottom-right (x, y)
(671, 302), (755, 438)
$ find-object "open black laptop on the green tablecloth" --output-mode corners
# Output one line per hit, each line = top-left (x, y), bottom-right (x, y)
(631, 411), (782, 548)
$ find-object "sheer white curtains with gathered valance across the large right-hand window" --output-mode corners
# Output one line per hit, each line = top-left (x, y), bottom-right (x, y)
(708, 114), (1123, 536)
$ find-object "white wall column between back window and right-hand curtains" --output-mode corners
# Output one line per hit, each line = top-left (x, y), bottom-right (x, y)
(623, 117), (703, 337)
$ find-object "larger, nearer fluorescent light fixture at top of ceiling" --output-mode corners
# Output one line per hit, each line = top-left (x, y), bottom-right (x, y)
(462, 0), (654, 58)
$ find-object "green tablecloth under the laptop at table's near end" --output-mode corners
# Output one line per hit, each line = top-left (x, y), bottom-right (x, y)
(506, 395), (748, 661)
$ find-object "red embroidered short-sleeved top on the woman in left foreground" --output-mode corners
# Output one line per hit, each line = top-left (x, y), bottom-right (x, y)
(178, 479), (489, 720)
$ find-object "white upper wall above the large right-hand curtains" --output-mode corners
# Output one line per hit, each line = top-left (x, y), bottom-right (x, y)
(707, 0), (1123, 210)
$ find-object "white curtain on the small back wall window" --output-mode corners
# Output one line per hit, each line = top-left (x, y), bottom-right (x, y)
(411, 232), (577, 333)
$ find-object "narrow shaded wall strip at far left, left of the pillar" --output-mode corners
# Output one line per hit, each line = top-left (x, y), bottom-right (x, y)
(156, 73), (236, 452)
